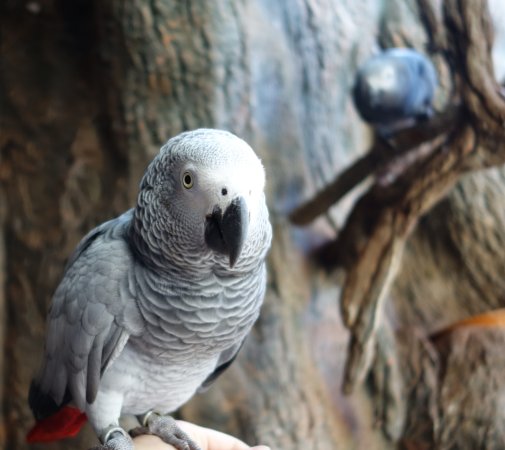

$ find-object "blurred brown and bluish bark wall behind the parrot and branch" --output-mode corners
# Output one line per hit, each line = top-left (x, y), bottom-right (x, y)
(0, 0), (505, 450)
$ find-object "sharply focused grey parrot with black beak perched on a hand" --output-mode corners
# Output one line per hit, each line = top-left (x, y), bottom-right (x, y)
(29, 129), (272, 450)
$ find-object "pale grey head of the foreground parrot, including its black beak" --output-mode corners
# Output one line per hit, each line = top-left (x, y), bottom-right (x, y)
(136, 129), (268, 268)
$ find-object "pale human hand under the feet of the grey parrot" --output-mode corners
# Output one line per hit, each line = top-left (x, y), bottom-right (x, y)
(133, 420), (270, 450)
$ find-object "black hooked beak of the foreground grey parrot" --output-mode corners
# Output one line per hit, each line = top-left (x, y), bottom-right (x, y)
(205, 197), (249, 267)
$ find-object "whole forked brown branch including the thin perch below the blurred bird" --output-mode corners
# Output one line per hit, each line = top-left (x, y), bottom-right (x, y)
(291, 0), (505, 392)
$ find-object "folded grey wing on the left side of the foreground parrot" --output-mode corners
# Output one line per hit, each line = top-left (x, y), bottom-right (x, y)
(29, 211), (143, 419)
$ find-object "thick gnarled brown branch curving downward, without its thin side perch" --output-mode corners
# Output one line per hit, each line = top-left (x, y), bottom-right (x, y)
(341, 0), (505, 391)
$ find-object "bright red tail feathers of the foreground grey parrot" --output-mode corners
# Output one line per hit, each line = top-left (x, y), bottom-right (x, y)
(26, 406), (87, 443)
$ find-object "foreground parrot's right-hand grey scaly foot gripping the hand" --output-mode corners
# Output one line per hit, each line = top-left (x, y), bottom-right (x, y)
(130, 411), (202, 450)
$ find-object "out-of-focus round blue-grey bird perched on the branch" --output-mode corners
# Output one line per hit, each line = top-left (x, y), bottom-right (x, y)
(353, 48), (438, 136)
